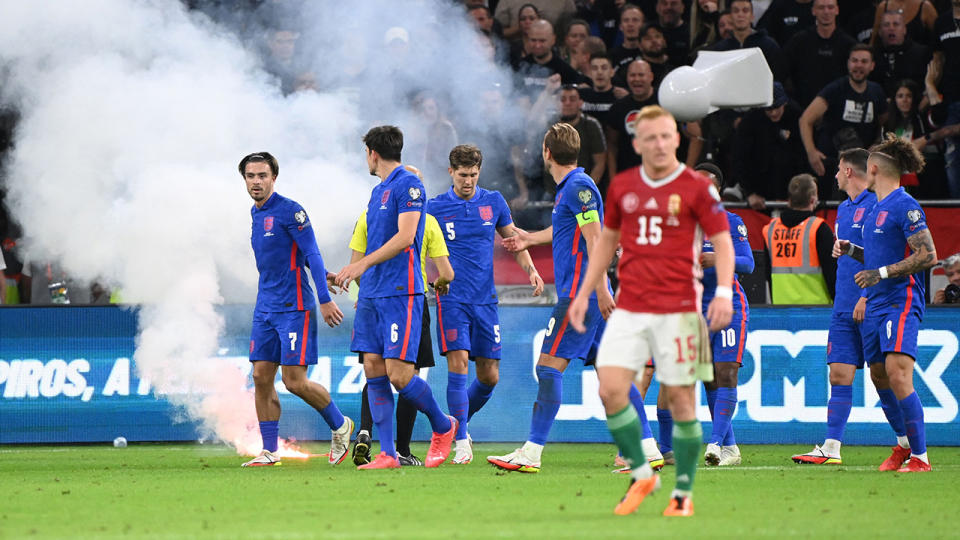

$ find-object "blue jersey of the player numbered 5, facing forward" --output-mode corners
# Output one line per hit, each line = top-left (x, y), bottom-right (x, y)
(427, 187), (513, 304)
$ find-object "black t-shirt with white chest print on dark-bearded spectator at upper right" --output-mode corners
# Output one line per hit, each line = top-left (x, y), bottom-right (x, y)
(817, 77), (887, 157)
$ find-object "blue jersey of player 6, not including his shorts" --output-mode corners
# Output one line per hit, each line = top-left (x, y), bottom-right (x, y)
(360, 166), (426, 298)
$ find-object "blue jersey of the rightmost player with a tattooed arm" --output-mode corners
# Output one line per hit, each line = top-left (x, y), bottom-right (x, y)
(863, 188), (927, 317)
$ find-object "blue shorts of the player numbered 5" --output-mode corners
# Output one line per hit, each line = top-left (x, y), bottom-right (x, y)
(437, 296), (503, 360)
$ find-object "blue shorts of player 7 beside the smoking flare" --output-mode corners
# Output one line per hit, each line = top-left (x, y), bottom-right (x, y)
(250, 310), (317, 366)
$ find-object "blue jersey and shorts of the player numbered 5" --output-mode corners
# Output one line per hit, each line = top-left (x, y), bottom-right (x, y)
(427, 187), (513, 360)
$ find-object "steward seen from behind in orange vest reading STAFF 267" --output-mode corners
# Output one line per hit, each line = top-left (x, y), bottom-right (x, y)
(763, 174), (837, 304)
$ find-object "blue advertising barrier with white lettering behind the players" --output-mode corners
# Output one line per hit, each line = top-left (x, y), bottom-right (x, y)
(0, 306), (960, 445)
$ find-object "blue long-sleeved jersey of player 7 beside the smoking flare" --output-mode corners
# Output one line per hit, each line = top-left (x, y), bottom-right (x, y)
(250, 192), (330, 312)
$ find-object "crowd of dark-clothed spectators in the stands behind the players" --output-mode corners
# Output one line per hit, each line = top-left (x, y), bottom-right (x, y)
(0, 0), (960, 303)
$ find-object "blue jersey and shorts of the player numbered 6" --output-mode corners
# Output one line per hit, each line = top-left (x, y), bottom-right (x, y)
(350, 166), (426, 362)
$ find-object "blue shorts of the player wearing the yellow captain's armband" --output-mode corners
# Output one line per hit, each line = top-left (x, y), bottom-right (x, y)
(540, 298), (607, 366)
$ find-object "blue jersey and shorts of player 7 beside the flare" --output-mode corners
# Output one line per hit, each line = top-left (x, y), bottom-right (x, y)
(250, 193), (330, 366)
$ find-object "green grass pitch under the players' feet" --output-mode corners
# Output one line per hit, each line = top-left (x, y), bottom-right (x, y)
(0, 443), (960, 540)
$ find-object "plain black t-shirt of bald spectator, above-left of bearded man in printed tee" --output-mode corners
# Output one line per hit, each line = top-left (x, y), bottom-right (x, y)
(783, 28), (860, 107)
